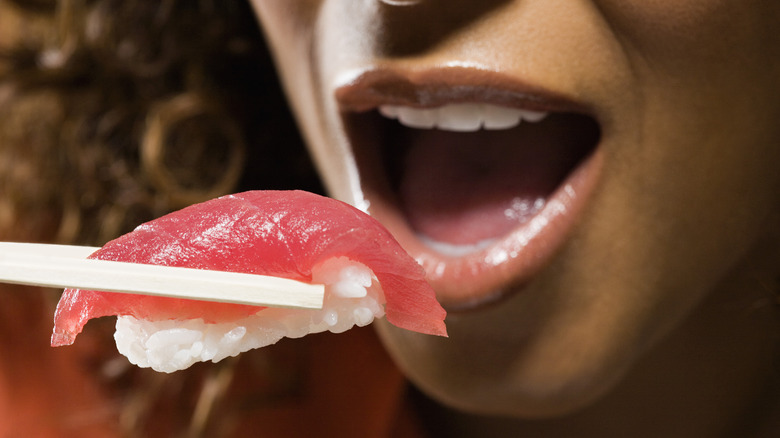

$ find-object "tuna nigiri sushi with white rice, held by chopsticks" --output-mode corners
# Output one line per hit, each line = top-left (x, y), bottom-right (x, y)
(51, 191), (446, 372)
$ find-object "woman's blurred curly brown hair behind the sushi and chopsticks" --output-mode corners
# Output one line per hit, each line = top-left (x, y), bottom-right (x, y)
(0, 0), (322, 436)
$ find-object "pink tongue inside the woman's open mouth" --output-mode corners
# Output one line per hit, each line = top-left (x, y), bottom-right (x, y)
(400, 117), (595, 245)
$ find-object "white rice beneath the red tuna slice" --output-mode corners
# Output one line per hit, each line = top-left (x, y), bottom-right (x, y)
(114, 257), (385, 373)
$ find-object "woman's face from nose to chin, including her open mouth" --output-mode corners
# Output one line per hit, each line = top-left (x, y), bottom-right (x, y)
(254, 0), (780, 415)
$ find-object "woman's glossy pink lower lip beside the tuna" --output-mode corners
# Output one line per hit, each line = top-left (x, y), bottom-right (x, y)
(364, 147), (603, 311)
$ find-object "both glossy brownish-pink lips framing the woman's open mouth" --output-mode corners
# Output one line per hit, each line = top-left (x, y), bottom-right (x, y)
(335, 67), (603, 311)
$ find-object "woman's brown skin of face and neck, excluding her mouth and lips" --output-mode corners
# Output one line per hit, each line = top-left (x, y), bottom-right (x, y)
(254, 0), (780, 436)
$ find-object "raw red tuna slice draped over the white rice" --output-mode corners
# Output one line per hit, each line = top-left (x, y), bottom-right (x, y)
(51, 191), (446, 370)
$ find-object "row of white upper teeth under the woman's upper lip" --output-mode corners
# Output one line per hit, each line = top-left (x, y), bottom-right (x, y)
(379, 103), (548, 131)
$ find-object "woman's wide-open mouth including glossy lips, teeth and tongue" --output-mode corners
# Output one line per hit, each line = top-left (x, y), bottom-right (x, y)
(337, 67), (601, 311)
